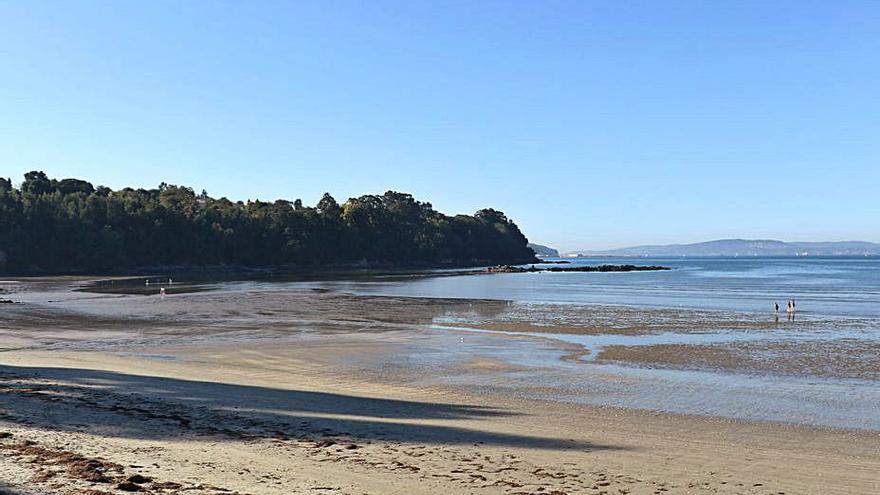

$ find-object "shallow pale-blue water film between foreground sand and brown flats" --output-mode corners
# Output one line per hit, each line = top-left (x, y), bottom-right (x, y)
(376, 328), (880, 431)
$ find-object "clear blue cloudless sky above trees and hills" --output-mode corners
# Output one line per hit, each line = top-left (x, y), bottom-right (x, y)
(0, 0), (880, 250)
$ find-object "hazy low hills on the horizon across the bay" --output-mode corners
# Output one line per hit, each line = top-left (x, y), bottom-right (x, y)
(570, 239), (880, 257)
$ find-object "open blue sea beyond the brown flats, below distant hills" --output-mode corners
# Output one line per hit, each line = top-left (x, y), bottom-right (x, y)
(302, 258), (880, 317)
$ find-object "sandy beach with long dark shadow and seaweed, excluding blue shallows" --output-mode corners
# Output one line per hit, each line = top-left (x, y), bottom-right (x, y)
(0, 279), (880, 495)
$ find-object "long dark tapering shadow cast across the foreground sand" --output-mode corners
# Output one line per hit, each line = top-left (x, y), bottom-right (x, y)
(0, 366), (618, 450)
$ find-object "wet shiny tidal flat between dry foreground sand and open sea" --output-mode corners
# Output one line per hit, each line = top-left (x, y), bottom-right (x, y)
(0, 281), (880, 429)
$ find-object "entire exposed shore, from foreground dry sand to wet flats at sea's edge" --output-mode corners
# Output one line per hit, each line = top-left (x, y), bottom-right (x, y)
(0, 278), (880, 494)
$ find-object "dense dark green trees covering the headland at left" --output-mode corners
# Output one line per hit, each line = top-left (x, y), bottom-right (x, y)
(0, 172), (534, 272)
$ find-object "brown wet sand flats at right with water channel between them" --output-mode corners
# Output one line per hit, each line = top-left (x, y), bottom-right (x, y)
(435, 304), (880, 381)
